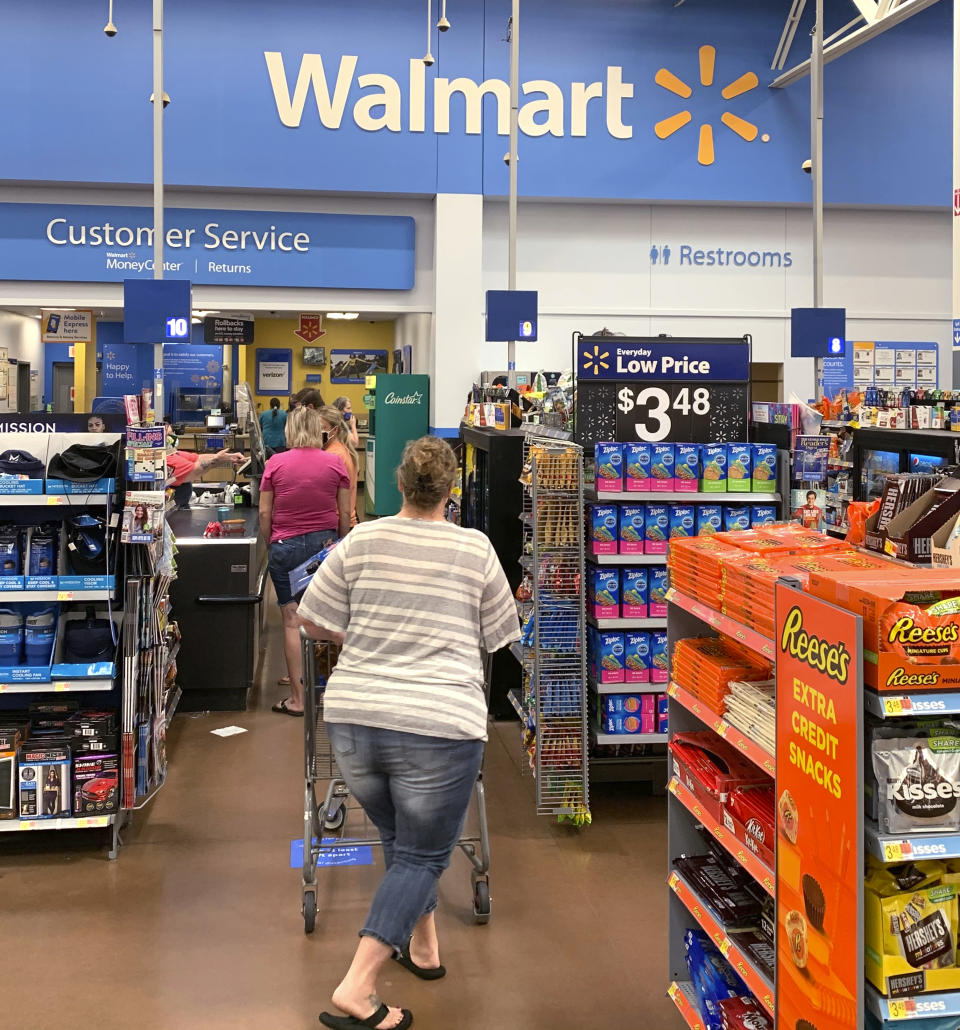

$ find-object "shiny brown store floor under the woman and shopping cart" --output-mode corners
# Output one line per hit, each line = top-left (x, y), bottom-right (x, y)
(0, 601), (681, 1030)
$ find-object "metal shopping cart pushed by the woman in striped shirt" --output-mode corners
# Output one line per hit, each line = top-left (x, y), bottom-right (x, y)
(300, 629), (490, 933)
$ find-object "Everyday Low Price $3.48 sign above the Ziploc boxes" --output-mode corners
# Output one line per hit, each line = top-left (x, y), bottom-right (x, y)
(576, 337), (750, 443)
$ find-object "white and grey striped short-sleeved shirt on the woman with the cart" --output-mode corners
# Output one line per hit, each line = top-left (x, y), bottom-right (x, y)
(299, 516), (520, 741)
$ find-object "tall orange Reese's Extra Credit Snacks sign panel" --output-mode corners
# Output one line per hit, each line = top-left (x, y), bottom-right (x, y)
(776, 583), (863, 1030)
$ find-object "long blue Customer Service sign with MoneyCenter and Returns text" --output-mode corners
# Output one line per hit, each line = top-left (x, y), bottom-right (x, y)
(0, 204), (415, 289)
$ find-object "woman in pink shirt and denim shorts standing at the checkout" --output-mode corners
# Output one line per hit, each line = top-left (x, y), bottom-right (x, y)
(260, 408), (350, 718)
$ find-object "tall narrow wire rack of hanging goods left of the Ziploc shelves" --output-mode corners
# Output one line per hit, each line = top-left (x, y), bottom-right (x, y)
(520, 433), (589, 822)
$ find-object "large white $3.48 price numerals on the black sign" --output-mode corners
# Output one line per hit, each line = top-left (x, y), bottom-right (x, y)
(617, 383), (713, 443)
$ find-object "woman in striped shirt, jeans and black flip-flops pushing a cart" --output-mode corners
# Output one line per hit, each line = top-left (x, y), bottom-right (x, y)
(299, 437), (520, 1030)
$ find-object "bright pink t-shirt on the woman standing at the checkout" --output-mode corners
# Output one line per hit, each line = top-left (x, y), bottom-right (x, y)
(260, 447), (350, 544)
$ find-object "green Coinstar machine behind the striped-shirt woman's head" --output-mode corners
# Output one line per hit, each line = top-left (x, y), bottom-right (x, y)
(364, 376), (430, 515)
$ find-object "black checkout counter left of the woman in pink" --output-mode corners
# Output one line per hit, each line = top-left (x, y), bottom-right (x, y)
(167, 496), (268, 712)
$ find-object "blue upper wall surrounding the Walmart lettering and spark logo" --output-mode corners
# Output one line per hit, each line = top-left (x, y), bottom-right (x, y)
(0, 0), (952, 206)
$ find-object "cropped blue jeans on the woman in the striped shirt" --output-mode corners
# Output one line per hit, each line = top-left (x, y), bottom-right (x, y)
(327, 723), (483, 950)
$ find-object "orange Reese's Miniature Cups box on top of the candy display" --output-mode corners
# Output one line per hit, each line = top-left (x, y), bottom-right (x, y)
(810, 563), (960, 691)
